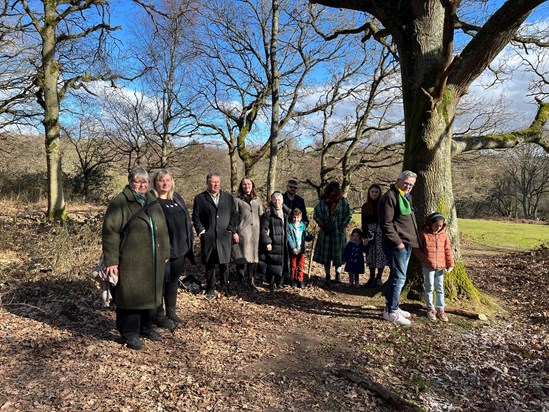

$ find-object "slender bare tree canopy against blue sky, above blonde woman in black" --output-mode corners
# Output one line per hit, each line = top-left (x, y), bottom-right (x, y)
(123, 0), (198, 168)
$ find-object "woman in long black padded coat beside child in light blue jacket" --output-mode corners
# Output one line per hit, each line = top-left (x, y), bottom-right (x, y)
(260, 192), (290, 292)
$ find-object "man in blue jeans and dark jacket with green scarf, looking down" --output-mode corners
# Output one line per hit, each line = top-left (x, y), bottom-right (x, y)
(379, 170), (419, 325)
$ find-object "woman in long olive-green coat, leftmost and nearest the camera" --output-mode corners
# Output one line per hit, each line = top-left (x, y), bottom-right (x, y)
(102, 166), (170, 349)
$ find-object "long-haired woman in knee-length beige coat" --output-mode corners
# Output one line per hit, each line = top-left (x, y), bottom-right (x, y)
(232, 177), (263, 290)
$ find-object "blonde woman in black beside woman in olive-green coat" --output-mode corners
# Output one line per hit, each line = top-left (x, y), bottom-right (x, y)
(153, 169), (195, 330)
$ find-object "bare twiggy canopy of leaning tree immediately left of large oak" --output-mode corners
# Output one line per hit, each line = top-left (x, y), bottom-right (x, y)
(302, 43), (402, 197)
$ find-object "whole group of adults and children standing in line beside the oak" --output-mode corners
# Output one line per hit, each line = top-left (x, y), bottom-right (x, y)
(102, 166), (453, 349)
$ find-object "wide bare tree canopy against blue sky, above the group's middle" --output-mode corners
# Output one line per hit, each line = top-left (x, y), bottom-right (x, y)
(193, 0), (382, 195)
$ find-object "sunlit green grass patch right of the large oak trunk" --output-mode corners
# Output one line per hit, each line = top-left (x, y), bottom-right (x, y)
(458, 219), (549, 250)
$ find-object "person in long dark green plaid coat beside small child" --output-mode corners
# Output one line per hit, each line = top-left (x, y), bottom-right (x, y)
(313, 182), (353, 286)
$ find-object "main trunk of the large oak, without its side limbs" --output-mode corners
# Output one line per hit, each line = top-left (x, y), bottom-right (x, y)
(396, 3), (479, 300)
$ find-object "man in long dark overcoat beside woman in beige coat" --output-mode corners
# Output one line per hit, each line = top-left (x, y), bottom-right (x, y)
(192, 173), (239, 299)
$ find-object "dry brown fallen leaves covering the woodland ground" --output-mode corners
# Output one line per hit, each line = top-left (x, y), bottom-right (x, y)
(0, 204), (549, 411)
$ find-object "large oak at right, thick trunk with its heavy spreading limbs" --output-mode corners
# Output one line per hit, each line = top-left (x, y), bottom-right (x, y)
(310, 0), (549, 306)
